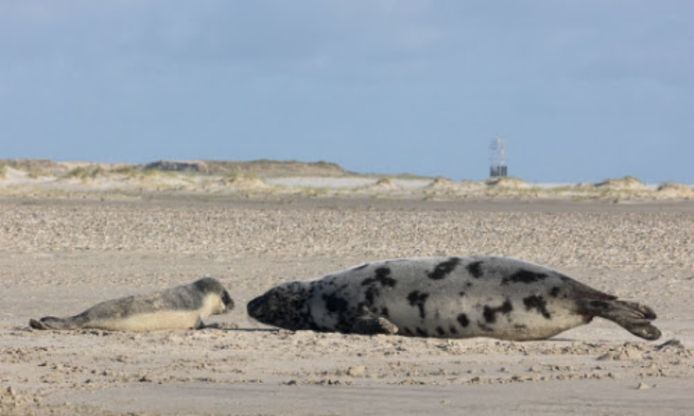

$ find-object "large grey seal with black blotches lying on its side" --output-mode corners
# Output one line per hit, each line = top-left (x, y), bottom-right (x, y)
(247, 257), (660, 340)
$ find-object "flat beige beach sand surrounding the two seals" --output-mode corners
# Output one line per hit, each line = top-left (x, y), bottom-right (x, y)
(0, 195), (694, 416)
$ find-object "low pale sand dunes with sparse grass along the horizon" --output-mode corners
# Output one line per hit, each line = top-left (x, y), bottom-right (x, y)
(0, 160), (694, 202)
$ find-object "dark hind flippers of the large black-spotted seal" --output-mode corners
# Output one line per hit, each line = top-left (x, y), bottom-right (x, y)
(578, 299), (661, 341)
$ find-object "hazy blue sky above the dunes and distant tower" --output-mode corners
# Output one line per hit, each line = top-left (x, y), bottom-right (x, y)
(0, 0), (694, 183)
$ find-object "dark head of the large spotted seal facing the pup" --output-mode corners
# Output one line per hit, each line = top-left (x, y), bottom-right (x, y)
(246, 282), (313, 331)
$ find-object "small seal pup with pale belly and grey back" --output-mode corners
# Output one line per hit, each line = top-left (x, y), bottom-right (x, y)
(29, 277), (234, 331)
